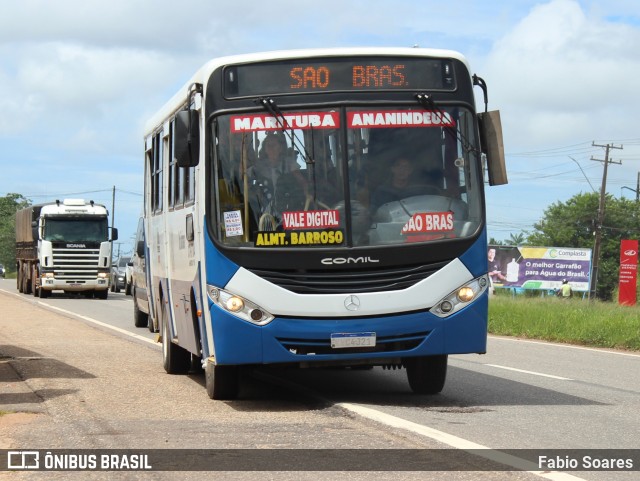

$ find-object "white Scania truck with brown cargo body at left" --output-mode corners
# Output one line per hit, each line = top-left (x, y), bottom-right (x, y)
(16, 199), (118, 299)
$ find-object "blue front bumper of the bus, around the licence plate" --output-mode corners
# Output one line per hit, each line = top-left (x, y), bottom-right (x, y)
(210, 292), (488, 365)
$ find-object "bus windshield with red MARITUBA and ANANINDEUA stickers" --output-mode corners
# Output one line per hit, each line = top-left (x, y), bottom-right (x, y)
(211, 106), (482, 248)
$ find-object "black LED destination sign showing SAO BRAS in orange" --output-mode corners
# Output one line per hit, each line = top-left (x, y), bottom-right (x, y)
(224, 57), (455, 98)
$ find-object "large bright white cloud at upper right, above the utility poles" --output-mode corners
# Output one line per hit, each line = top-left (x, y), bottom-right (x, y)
(486, 0), (640, 145)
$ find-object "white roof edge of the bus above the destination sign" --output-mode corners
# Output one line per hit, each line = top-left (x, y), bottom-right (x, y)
(144, 47), (469, 138)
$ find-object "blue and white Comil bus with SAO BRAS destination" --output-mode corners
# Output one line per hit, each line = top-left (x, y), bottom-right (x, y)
(144, 48), (507, 399)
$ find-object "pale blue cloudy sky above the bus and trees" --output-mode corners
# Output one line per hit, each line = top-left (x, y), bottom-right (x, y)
(0, 0), (640, 254)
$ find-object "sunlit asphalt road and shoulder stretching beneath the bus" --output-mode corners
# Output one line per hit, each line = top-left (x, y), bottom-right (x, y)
(0, 280), (640, 480)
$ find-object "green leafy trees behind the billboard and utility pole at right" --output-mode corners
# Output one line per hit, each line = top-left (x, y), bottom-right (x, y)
(527, 193), (640, 300)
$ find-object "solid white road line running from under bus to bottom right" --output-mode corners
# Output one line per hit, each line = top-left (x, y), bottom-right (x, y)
(336, 403), (584, 481)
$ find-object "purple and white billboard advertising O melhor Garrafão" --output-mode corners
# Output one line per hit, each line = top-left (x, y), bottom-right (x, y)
(487, 245), (591, 292)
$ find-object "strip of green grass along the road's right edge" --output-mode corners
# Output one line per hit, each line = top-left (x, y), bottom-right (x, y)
(489, 296), (640, 351)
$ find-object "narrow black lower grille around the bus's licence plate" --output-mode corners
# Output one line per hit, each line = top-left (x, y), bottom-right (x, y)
(278, 331), (431, 355)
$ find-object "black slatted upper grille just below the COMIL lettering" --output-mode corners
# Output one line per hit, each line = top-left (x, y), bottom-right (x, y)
(249, 261), (449, 294)
